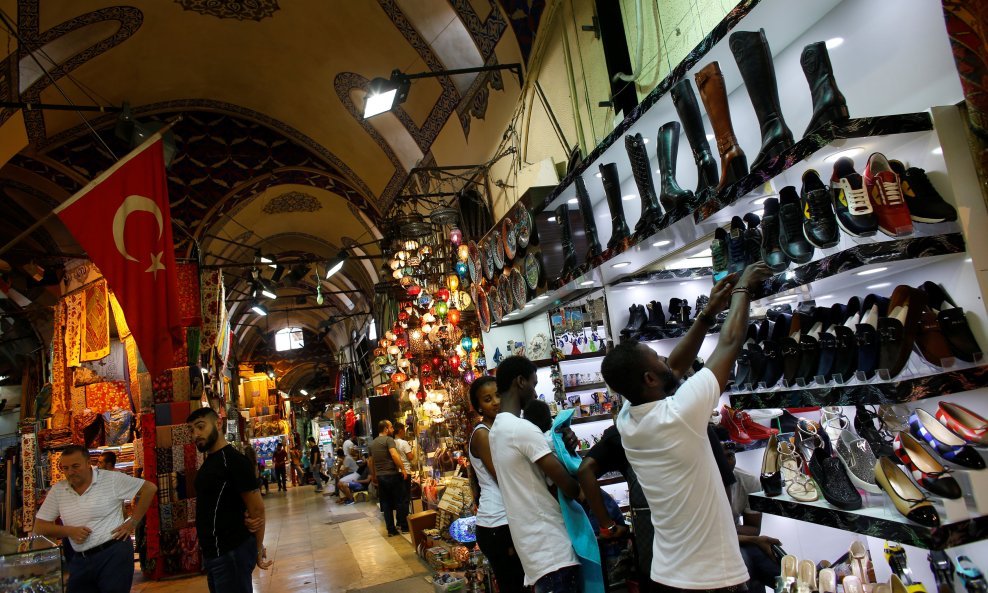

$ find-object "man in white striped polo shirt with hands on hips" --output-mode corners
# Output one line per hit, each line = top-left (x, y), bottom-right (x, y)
(34, 445), (158, 593)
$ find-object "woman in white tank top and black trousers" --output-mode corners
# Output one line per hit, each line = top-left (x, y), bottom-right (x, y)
(468, 377), (526, 593)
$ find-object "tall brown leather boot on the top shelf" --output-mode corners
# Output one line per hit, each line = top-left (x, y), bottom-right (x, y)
(695, 62), (748, 192)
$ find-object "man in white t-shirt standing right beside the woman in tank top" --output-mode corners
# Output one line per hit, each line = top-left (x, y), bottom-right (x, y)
(490, 356), (582, 593)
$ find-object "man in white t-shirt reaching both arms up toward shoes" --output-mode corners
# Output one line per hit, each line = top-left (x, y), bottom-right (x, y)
(601, 262), (771, 592)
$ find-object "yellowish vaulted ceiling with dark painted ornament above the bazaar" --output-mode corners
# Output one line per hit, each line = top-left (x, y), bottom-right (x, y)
(0, 0), (544, 384)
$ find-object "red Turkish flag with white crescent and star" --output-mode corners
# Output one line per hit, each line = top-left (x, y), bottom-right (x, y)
(55, 136), (182, 375)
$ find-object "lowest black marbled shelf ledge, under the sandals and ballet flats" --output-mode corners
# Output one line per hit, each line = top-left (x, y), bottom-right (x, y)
(748, 494), (988, 550)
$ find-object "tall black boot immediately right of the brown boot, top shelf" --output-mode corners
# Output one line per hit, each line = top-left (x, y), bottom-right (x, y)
(730, 29), (794, 169)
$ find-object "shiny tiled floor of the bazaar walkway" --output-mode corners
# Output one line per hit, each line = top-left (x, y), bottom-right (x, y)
(133, 486), (432, 593)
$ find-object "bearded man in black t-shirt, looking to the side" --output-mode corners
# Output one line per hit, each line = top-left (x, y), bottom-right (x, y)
(186, 408), (272, 593)
